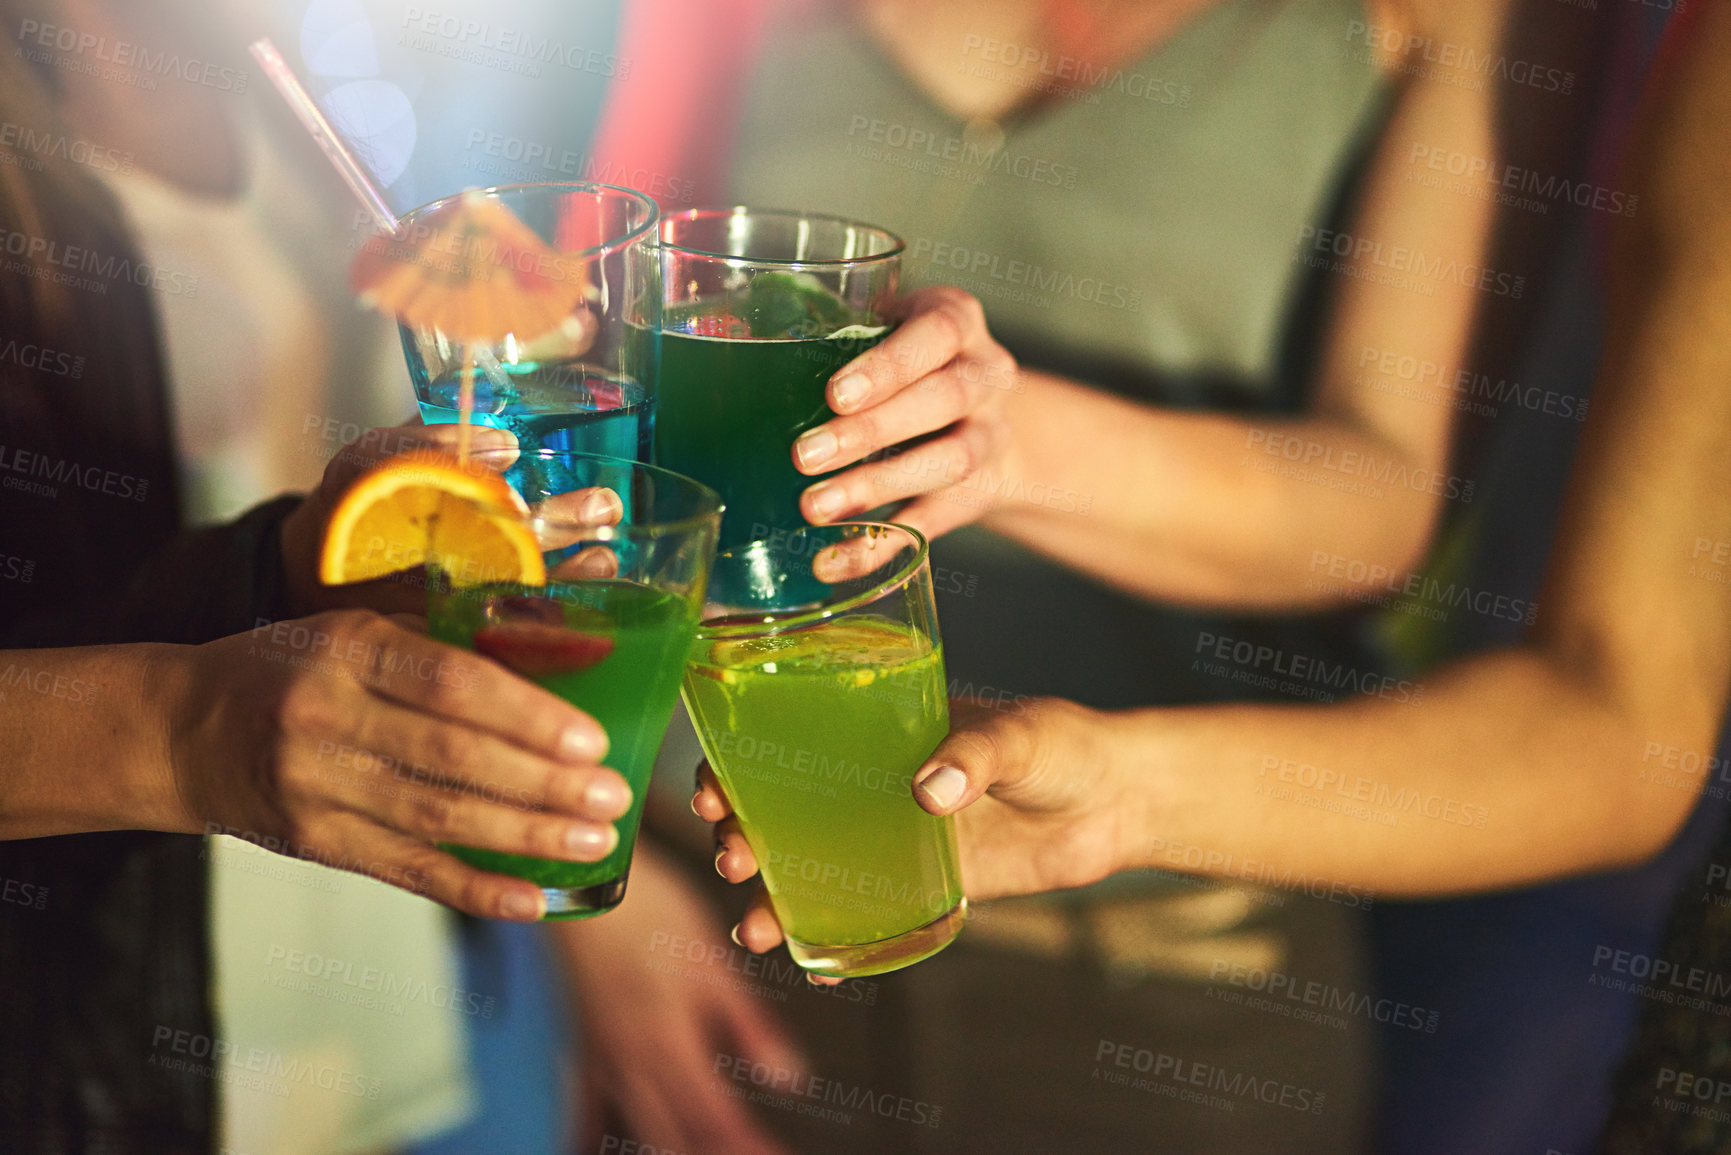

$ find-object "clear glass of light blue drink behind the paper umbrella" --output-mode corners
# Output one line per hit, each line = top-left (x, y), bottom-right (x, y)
(398, 184), (661, 461)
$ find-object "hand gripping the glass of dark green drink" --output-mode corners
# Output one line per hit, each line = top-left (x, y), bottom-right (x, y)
(793, 286), (1020, 537)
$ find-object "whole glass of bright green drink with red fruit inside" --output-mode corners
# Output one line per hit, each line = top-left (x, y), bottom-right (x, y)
(428, 450), (720, 918)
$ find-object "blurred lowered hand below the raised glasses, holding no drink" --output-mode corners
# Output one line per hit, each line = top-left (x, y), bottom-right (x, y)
(554, 843), (805, 1155)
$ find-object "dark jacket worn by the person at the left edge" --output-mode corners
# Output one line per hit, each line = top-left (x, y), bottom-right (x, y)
(0, 167), (293, 1155)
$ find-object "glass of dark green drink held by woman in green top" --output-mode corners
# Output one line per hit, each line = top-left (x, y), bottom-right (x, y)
(654, 208), (902, 549)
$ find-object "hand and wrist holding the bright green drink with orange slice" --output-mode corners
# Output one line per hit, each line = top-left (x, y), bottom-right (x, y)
(159, 610), (632, 921)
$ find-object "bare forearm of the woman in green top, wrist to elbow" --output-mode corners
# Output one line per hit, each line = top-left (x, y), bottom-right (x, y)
(978, 374), (1449, 610)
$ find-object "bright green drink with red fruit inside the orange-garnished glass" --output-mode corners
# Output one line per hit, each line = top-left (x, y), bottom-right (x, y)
(428, 580), (698, 918)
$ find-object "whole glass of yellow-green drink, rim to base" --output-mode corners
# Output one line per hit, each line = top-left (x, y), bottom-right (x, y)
(684, 523), (966, 977)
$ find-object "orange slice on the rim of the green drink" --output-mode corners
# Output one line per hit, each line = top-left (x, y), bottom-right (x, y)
(319, 448), (547, 585)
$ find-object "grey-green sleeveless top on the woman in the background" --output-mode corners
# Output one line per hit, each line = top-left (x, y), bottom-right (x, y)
(730, 0), (1381, 402)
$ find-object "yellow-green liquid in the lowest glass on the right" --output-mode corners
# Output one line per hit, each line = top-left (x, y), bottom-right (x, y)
(685, 618), (962, 965)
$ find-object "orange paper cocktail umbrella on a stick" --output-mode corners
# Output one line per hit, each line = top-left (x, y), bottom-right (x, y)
(350, 192), (592, 455)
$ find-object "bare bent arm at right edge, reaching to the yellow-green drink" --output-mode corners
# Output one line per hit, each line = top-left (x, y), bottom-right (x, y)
(928, 5), (1731, 895)
